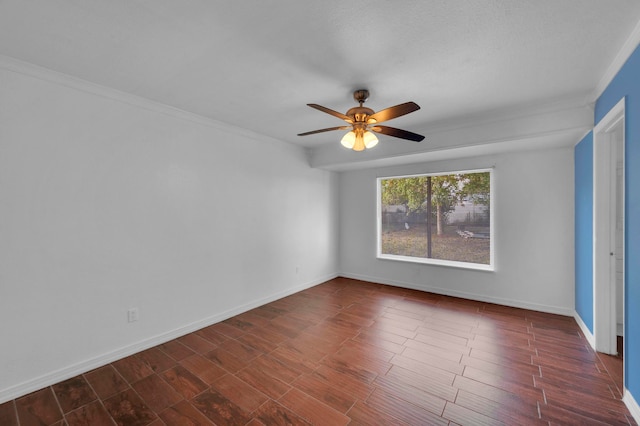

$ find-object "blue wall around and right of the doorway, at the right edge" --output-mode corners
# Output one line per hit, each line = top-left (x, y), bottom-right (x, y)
(595, 43), (640, 400)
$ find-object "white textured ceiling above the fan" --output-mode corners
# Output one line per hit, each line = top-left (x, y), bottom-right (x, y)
(0, 0), (640, 160)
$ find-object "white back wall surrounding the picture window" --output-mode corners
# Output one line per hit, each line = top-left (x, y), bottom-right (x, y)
(340, 148), (574, 315)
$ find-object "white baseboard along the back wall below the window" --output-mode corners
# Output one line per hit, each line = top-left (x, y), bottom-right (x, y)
(340, 273), (574, 317)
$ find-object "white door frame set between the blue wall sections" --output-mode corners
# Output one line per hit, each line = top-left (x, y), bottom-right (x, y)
(593, 98), (625, 355)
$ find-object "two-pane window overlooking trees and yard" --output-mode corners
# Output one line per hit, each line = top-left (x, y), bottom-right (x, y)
(378, 169), (493, 270)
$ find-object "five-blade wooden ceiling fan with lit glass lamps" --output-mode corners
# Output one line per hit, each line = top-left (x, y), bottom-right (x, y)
(298, 89), (424, 151)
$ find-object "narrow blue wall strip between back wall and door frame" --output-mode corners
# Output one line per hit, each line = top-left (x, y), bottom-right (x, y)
(574, 132), (593, 334)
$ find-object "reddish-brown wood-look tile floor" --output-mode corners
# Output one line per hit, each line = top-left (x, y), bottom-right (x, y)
(0, 278), (636, 426)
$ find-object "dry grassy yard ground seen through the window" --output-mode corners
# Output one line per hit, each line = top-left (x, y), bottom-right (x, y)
(382, 225), (490, 265)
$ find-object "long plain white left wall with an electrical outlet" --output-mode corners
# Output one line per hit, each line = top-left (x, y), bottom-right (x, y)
(0, 64), (338, 403)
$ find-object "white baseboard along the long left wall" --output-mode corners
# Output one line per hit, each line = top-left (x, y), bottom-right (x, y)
(0, 274), (338, 404)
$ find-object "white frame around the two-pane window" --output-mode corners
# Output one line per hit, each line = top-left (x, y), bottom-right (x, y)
(376, 167), (495, 271)
